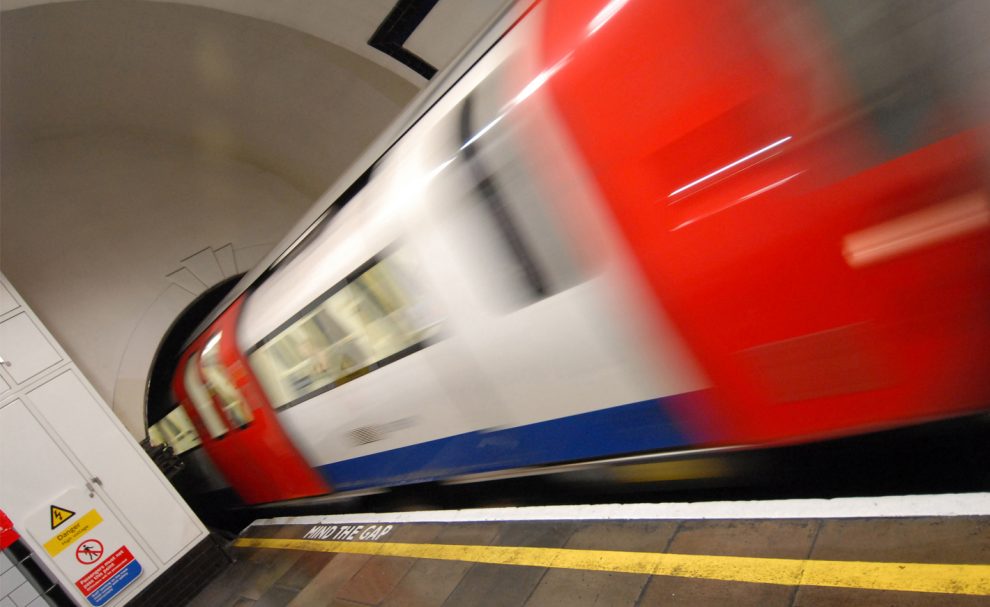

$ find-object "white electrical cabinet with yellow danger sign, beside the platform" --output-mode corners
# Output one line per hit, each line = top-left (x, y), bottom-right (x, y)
(0, 276), (208, 607)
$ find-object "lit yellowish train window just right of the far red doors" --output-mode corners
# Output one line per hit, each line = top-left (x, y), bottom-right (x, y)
(250, 252), (439, 407)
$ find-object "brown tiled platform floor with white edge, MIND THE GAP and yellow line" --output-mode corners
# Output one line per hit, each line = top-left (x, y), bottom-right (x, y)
(191, 494), (990, 607)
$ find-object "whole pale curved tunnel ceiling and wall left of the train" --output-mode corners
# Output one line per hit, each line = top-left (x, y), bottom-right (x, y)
(0, 0), (505, 436)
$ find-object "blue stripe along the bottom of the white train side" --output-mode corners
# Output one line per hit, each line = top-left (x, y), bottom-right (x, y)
(317, 393), (698, 491)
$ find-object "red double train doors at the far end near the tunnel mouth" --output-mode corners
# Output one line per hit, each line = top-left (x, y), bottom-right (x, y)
(173, 300), (330, 504)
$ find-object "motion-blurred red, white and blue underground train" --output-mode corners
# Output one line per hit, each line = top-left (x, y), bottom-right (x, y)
(151, 0), (990, 504)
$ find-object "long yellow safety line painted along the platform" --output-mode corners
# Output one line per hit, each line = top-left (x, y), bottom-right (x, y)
(234, 538), (990, 596)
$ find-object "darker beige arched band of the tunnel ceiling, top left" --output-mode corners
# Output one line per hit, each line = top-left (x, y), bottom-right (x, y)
(2, 1), (426, 196)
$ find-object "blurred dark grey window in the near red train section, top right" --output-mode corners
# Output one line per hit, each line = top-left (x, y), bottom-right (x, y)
(814, 0), (988, 157)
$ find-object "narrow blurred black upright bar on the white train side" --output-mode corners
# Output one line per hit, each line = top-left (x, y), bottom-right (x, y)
(460, 95), (550, 299)
